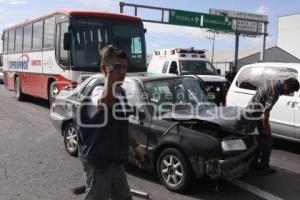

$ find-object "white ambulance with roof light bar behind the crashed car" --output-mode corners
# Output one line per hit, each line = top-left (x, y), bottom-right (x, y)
(147, 48), (230, 105)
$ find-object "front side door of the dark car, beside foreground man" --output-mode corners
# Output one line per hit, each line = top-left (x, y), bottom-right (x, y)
(122, 81), (151, 152)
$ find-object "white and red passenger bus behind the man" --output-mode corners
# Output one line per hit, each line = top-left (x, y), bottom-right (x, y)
(1, 10), (147, 102)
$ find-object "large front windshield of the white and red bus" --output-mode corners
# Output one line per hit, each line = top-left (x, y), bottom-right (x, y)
(71, 18), (146, 72)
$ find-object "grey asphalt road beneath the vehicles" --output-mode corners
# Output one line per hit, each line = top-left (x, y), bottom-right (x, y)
(0, 85), (300, 200)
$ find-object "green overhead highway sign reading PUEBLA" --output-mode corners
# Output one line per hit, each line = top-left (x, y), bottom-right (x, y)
(169, 10), (232, 31)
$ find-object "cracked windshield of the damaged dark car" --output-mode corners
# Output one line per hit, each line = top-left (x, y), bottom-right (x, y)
(144, 77), (211, 114)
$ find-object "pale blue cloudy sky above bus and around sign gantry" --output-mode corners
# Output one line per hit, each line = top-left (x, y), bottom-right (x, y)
(0, 0), (300, 59)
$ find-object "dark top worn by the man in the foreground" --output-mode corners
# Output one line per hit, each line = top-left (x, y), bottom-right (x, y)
(78, 83), (129, 164)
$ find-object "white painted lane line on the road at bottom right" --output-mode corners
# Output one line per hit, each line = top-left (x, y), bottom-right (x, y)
(230, 179), (283, 200)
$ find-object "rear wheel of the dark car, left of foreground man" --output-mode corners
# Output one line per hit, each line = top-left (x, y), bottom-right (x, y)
(63, 122), (78, 156)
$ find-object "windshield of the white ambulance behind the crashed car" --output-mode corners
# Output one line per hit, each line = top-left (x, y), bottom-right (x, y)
(179, 60), (218, 75)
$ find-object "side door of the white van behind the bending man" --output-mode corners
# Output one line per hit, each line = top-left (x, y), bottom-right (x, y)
(261, 67), (298, 138)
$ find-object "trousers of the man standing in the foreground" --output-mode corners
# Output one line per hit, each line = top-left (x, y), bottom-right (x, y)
(83, 163), (132, 200)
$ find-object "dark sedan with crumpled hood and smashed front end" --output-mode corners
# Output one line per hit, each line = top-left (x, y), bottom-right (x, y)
(51, 75), (257, 191)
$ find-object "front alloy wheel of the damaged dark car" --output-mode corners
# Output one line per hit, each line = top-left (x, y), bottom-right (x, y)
(156, 148), (192, 192)
